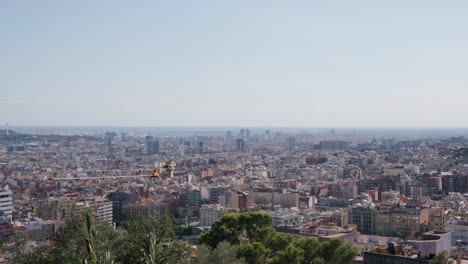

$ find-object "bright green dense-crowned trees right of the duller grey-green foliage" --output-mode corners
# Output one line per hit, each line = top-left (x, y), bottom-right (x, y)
(201, 212), (358, 264)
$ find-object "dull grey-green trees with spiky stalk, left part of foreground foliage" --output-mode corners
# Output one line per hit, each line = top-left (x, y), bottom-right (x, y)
(12, 214), (190, 264)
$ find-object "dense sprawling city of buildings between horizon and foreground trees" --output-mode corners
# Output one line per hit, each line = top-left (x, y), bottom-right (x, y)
(0, 128), (468, 263)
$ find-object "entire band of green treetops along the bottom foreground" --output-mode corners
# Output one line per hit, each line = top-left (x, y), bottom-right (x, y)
(8, 212), (358, 264)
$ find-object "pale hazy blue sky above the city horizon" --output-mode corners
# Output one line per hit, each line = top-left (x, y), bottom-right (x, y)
(0, 0), (468, 127)
